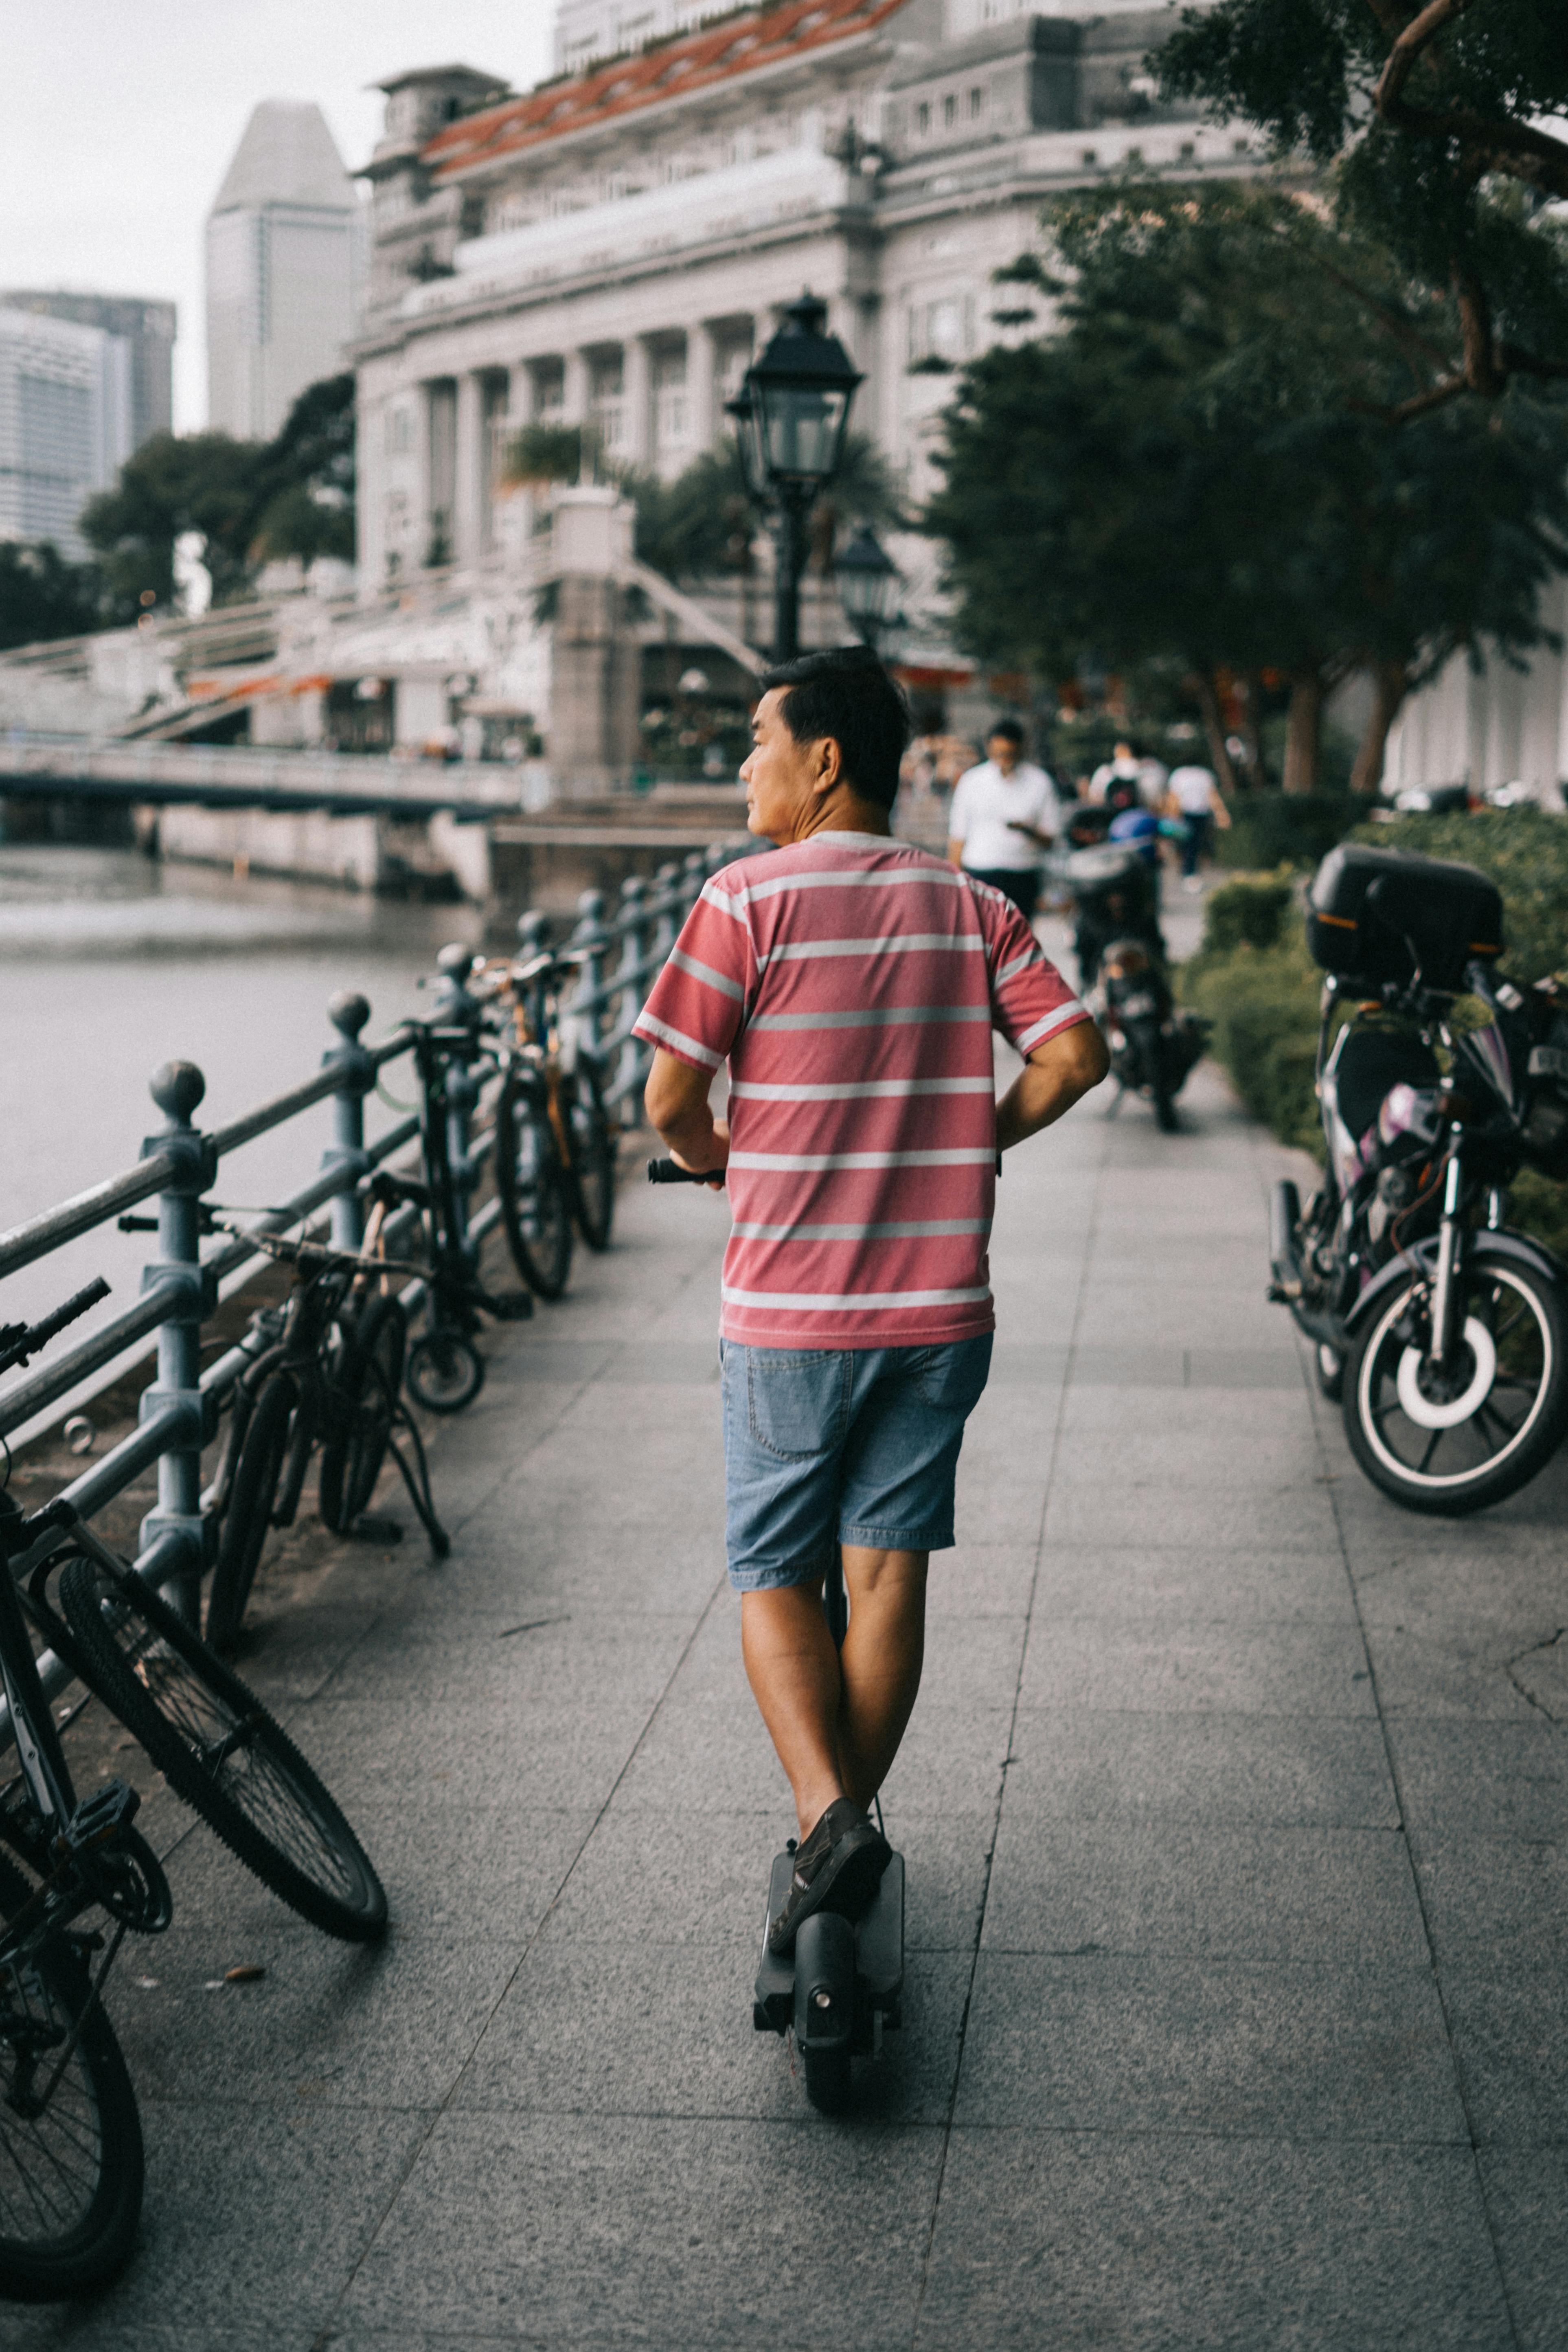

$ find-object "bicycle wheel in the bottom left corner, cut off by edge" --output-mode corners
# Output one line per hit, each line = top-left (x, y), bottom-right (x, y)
(0, 1861), (141, 2303)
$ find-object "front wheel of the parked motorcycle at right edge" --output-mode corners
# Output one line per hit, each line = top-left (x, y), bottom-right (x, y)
(1342, 1242), (1568, 1519)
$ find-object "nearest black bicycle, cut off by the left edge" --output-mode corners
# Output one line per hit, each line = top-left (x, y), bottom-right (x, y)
(0, 1282), (386, 2300)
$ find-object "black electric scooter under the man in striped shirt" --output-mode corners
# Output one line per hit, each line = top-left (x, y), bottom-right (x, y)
(649, 1160), (903, 2115)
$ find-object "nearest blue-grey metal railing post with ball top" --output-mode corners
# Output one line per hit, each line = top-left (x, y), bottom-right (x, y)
(136, 1061), (219, 1625)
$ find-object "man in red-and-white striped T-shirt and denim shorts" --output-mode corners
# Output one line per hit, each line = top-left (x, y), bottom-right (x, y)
(635, 647), (1107, 2098)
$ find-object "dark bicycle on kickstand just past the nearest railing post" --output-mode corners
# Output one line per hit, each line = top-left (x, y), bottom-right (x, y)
(202, 1213), (452, 1649)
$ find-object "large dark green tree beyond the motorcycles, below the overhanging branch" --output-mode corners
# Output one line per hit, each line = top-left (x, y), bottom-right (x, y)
(926, 184), (1568, 790)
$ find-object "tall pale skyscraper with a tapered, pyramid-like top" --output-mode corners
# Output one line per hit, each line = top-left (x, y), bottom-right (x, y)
(207, 99), (360, 440)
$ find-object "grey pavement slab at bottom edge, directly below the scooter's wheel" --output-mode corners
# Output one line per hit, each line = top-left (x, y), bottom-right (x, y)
(334, 2112), (943, 2352)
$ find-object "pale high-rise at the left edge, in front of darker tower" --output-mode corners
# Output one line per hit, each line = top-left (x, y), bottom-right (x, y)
(0, 306), (132, 560)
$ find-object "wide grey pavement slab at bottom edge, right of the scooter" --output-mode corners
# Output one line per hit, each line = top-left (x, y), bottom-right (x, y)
(914, 2131), (1504, 2352)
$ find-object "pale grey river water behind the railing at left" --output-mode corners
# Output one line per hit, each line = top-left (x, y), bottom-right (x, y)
(0, 845), (491, 1430)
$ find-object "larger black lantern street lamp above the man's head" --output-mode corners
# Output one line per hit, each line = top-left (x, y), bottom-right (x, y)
(729, 294), (863, 661)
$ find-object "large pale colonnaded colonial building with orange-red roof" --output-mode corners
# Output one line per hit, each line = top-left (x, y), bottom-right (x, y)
(355, 0), (1255, 593)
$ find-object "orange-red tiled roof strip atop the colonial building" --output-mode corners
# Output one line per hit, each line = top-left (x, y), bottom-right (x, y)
(421, 0), (905, 179)
